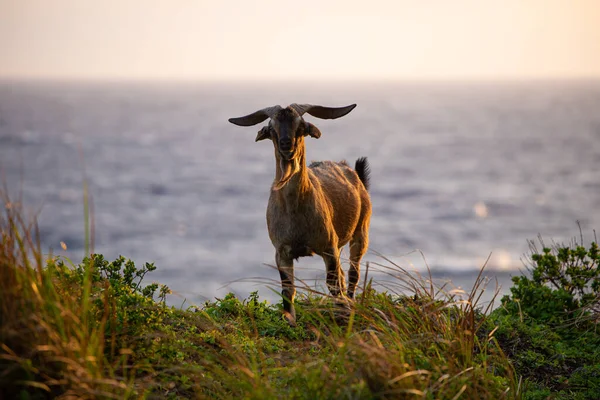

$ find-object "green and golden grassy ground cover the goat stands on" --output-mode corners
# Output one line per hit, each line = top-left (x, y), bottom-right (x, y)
(0, 189), (598, 399)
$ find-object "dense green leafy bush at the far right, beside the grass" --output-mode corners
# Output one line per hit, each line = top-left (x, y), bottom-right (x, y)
(490, 239), (600, 399)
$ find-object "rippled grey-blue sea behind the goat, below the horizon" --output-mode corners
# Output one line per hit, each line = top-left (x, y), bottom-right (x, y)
(0, 81), (600, 301)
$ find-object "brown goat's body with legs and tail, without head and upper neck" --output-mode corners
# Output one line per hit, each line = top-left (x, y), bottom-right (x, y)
(267, 154), (371, 310)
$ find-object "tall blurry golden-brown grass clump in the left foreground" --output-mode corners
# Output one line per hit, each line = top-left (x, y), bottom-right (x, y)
(0, 190), (131, 399)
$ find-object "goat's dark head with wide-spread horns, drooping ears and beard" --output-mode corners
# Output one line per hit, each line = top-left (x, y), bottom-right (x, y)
(229, 104), (356, 189)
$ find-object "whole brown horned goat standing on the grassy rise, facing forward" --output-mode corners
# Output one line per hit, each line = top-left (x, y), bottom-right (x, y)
(229, 104), (371, 325)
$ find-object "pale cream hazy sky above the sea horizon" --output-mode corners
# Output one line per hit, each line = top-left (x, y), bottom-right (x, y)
(0, 0), (600, 80)
